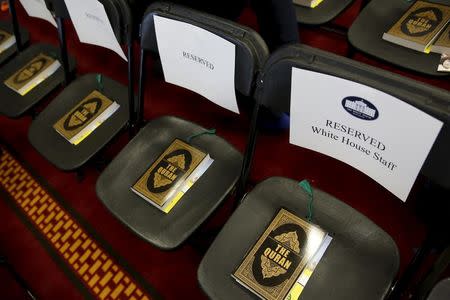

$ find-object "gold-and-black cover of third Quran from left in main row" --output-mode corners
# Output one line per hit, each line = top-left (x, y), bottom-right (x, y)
(53, 90), (118, 144)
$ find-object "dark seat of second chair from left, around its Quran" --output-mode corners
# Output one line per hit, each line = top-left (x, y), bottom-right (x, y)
(0, 44), (75, 118)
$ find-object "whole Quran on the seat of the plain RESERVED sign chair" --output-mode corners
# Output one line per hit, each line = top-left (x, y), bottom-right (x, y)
(131, 139), (214, 213)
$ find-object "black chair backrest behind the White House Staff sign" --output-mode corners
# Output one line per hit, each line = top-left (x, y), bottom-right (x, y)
(256, 45), (450, 189)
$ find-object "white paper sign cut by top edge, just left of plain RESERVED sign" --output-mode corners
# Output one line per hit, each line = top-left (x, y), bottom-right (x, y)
(64, 0), (128, 61)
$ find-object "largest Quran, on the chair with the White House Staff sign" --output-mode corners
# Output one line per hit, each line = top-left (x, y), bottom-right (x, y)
(231, 209), (330, 300)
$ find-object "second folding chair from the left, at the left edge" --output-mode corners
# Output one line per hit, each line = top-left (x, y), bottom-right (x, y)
(0, 0), (75, 118)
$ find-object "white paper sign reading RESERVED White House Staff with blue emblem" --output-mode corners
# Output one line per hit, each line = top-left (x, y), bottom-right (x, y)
(290, 68), (443, 201)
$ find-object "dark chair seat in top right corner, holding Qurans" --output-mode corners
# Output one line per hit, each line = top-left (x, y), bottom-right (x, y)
(348, 0), (449, 76)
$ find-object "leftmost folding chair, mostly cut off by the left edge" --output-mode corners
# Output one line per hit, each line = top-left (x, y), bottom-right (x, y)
(0, 0), (29, 65)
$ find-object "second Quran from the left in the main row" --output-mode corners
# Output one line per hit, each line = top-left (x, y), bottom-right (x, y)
(5, 53), (61, 96)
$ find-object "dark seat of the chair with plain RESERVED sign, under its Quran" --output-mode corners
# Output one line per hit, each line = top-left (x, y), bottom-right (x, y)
(96, 116), (242, 250)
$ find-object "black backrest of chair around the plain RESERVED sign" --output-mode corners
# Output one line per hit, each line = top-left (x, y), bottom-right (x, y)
(141, 2), (269, 96)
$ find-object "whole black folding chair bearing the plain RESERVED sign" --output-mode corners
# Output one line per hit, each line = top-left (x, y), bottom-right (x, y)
(96, 3), (268, 249)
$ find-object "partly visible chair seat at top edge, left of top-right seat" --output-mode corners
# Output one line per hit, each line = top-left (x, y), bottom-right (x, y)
(294, 0), (354, 25)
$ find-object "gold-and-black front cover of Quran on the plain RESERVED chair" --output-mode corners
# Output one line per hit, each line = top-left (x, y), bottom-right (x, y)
(132, 139), (208, 207)
